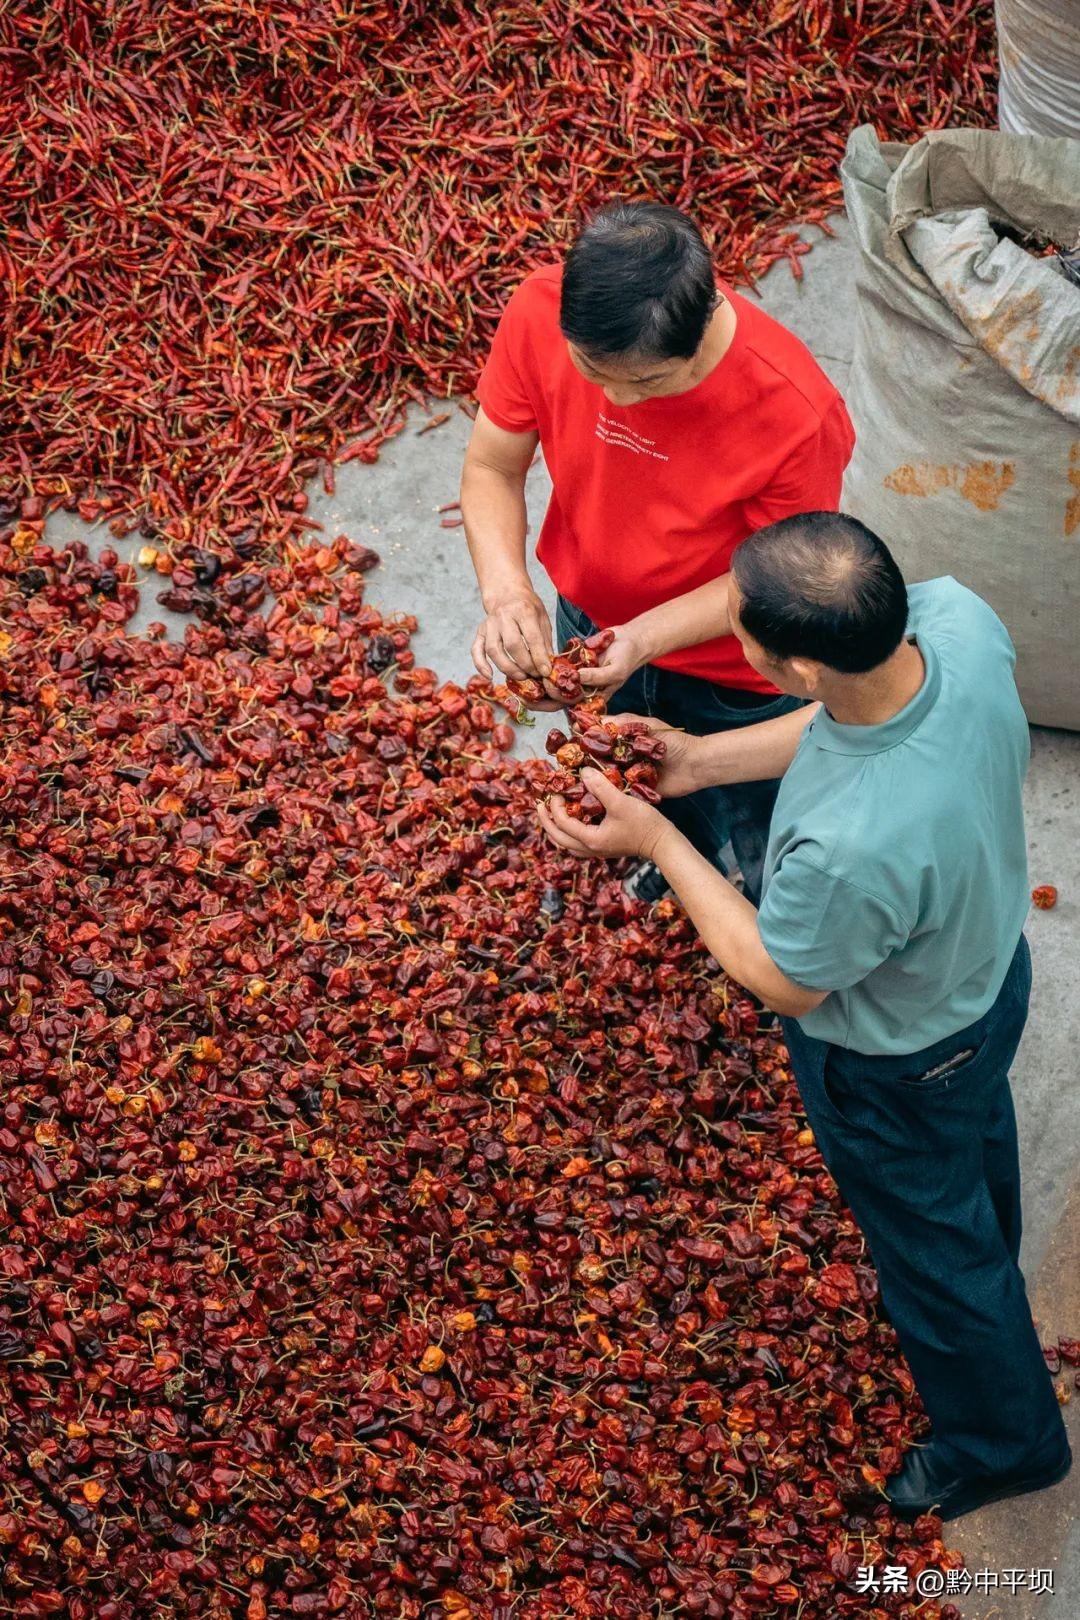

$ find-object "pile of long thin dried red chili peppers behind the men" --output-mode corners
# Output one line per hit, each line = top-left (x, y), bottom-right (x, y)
(0, 0), (994, 556)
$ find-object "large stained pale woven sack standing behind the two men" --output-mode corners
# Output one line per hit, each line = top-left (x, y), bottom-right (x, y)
(840, 126), (1080, 729)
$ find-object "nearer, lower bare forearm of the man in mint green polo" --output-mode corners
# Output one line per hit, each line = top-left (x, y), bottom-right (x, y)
(653, 825), (824, 1017)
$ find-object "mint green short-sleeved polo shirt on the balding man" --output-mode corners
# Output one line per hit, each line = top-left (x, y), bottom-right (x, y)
(758, 578), (1030, 1055)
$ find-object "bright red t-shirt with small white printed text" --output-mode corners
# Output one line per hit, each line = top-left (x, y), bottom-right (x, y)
(476, 264), (855, 692)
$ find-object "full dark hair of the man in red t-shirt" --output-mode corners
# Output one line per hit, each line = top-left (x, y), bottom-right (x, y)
(559, 203), (717, 360)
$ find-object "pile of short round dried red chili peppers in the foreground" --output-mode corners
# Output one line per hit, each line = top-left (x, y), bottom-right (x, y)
(0, 534), (1003, 1620)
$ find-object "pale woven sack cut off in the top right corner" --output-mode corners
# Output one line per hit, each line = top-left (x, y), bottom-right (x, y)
(997, 0), (1080, 136)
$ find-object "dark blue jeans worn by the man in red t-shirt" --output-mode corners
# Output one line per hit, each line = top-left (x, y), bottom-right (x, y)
(555, 596), (801, 906)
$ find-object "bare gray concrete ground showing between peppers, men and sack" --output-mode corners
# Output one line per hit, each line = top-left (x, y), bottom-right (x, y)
(38, 220), (1080, 1620)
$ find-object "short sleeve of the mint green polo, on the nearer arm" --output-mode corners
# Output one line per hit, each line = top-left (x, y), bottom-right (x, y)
(758, 846), (908, 991)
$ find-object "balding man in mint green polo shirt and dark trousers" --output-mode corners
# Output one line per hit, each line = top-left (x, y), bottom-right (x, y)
(539, 512), (1072, 1518)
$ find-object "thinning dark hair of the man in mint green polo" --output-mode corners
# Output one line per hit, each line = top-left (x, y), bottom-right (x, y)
(732, 512), (907, 676)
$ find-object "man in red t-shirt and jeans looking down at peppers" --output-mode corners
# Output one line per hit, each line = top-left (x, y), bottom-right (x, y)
(461, 203), (853, 901)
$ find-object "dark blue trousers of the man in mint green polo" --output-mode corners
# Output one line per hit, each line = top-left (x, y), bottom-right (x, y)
(784, 936), (1064, 1473)
